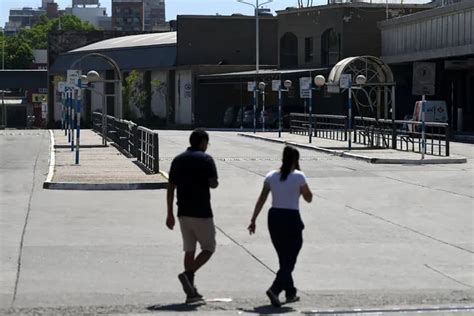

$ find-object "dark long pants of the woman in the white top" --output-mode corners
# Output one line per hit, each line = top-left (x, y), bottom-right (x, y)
(268, 208), (304, 297)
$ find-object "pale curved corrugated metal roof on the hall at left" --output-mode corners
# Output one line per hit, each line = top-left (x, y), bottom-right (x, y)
(69, 32), (176, 53)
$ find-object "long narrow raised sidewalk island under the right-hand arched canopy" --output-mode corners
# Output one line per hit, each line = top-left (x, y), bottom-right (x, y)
(238, 132), (467, 164)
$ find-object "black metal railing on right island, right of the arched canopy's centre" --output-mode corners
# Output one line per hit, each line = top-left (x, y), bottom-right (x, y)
(354, 116), (449, 156)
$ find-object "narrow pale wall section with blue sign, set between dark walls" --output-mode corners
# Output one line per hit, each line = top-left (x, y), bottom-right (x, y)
(175, 70), (193, 125)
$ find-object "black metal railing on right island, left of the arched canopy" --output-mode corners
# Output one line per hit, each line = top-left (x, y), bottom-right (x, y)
(290, 113), (347, 141)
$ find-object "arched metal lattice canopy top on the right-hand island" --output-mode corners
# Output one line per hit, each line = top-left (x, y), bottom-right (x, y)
(328, 56), (394, 85)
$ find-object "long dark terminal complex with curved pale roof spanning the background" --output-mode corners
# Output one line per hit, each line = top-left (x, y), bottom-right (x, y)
(50, 1), (474, 130)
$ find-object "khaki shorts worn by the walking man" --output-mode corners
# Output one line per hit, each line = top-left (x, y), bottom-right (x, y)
(178, 216), (216, 252)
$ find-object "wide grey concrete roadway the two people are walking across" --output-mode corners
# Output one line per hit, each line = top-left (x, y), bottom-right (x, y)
(0, 131), (474, 315)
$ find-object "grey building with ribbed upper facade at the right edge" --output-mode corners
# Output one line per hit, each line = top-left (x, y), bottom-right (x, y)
(379, 0), (474, 133)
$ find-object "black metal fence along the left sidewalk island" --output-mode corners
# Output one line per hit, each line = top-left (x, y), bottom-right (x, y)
(92, 112), (160, 173)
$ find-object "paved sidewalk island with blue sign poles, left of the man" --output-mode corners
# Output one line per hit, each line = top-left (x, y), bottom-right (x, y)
(43, 130), (167, 190)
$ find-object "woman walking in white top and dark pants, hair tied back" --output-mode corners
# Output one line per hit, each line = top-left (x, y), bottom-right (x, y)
(248, 146), (313, 307)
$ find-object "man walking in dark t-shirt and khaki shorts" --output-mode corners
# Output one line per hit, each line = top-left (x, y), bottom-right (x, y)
(166, 129), (219, 303)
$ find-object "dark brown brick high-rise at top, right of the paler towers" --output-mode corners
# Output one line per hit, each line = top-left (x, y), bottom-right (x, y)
(112, 0), (145, 31)
